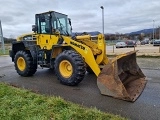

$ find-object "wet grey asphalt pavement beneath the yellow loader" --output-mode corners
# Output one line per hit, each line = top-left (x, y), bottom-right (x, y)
(0, 56), (160, 120)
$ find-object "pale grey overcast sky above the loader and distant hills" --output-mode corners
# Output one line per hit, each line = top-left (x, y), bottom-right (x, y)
(0, 0), (160, 38)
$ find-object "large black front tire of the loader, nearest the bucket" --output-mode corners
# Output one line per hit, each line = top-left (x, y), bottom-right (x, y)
(54, 50), (86, 86)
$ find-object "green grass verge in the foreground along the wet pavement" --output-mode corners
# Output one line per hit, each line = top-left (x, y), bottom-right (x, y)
(0, 83), (125, 120)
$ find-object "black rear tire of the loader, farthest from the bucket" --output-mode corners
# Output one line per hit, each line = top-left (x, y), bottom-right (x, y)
(14, 51), (37, 77)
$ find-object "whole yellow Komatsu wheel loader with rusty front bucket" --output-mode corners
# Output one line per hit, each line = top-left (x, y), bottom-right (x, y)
(10, 11), (146, 102)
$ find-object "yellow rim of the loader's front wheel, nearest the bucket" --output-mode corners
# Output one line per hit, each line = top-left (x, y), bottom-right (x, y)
(59, 60), (73, 78)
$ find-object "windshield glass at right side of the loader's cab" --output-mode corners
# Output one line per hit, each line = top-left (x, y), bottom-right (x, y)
(51, 12), (71, 35)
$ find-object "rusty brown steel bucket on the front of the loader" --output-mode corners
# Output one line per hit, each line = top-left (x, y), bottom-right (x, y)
(97, 51), (147, 102)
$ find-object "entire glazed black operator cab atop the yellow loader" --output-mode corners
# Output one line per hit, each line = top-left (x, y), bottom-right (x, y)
(32, 11), (72, 36)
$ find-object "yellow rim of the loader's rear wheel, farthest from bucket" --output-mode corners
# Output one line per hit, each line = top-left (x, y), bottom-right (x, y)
(17, 57), (26, 71)
